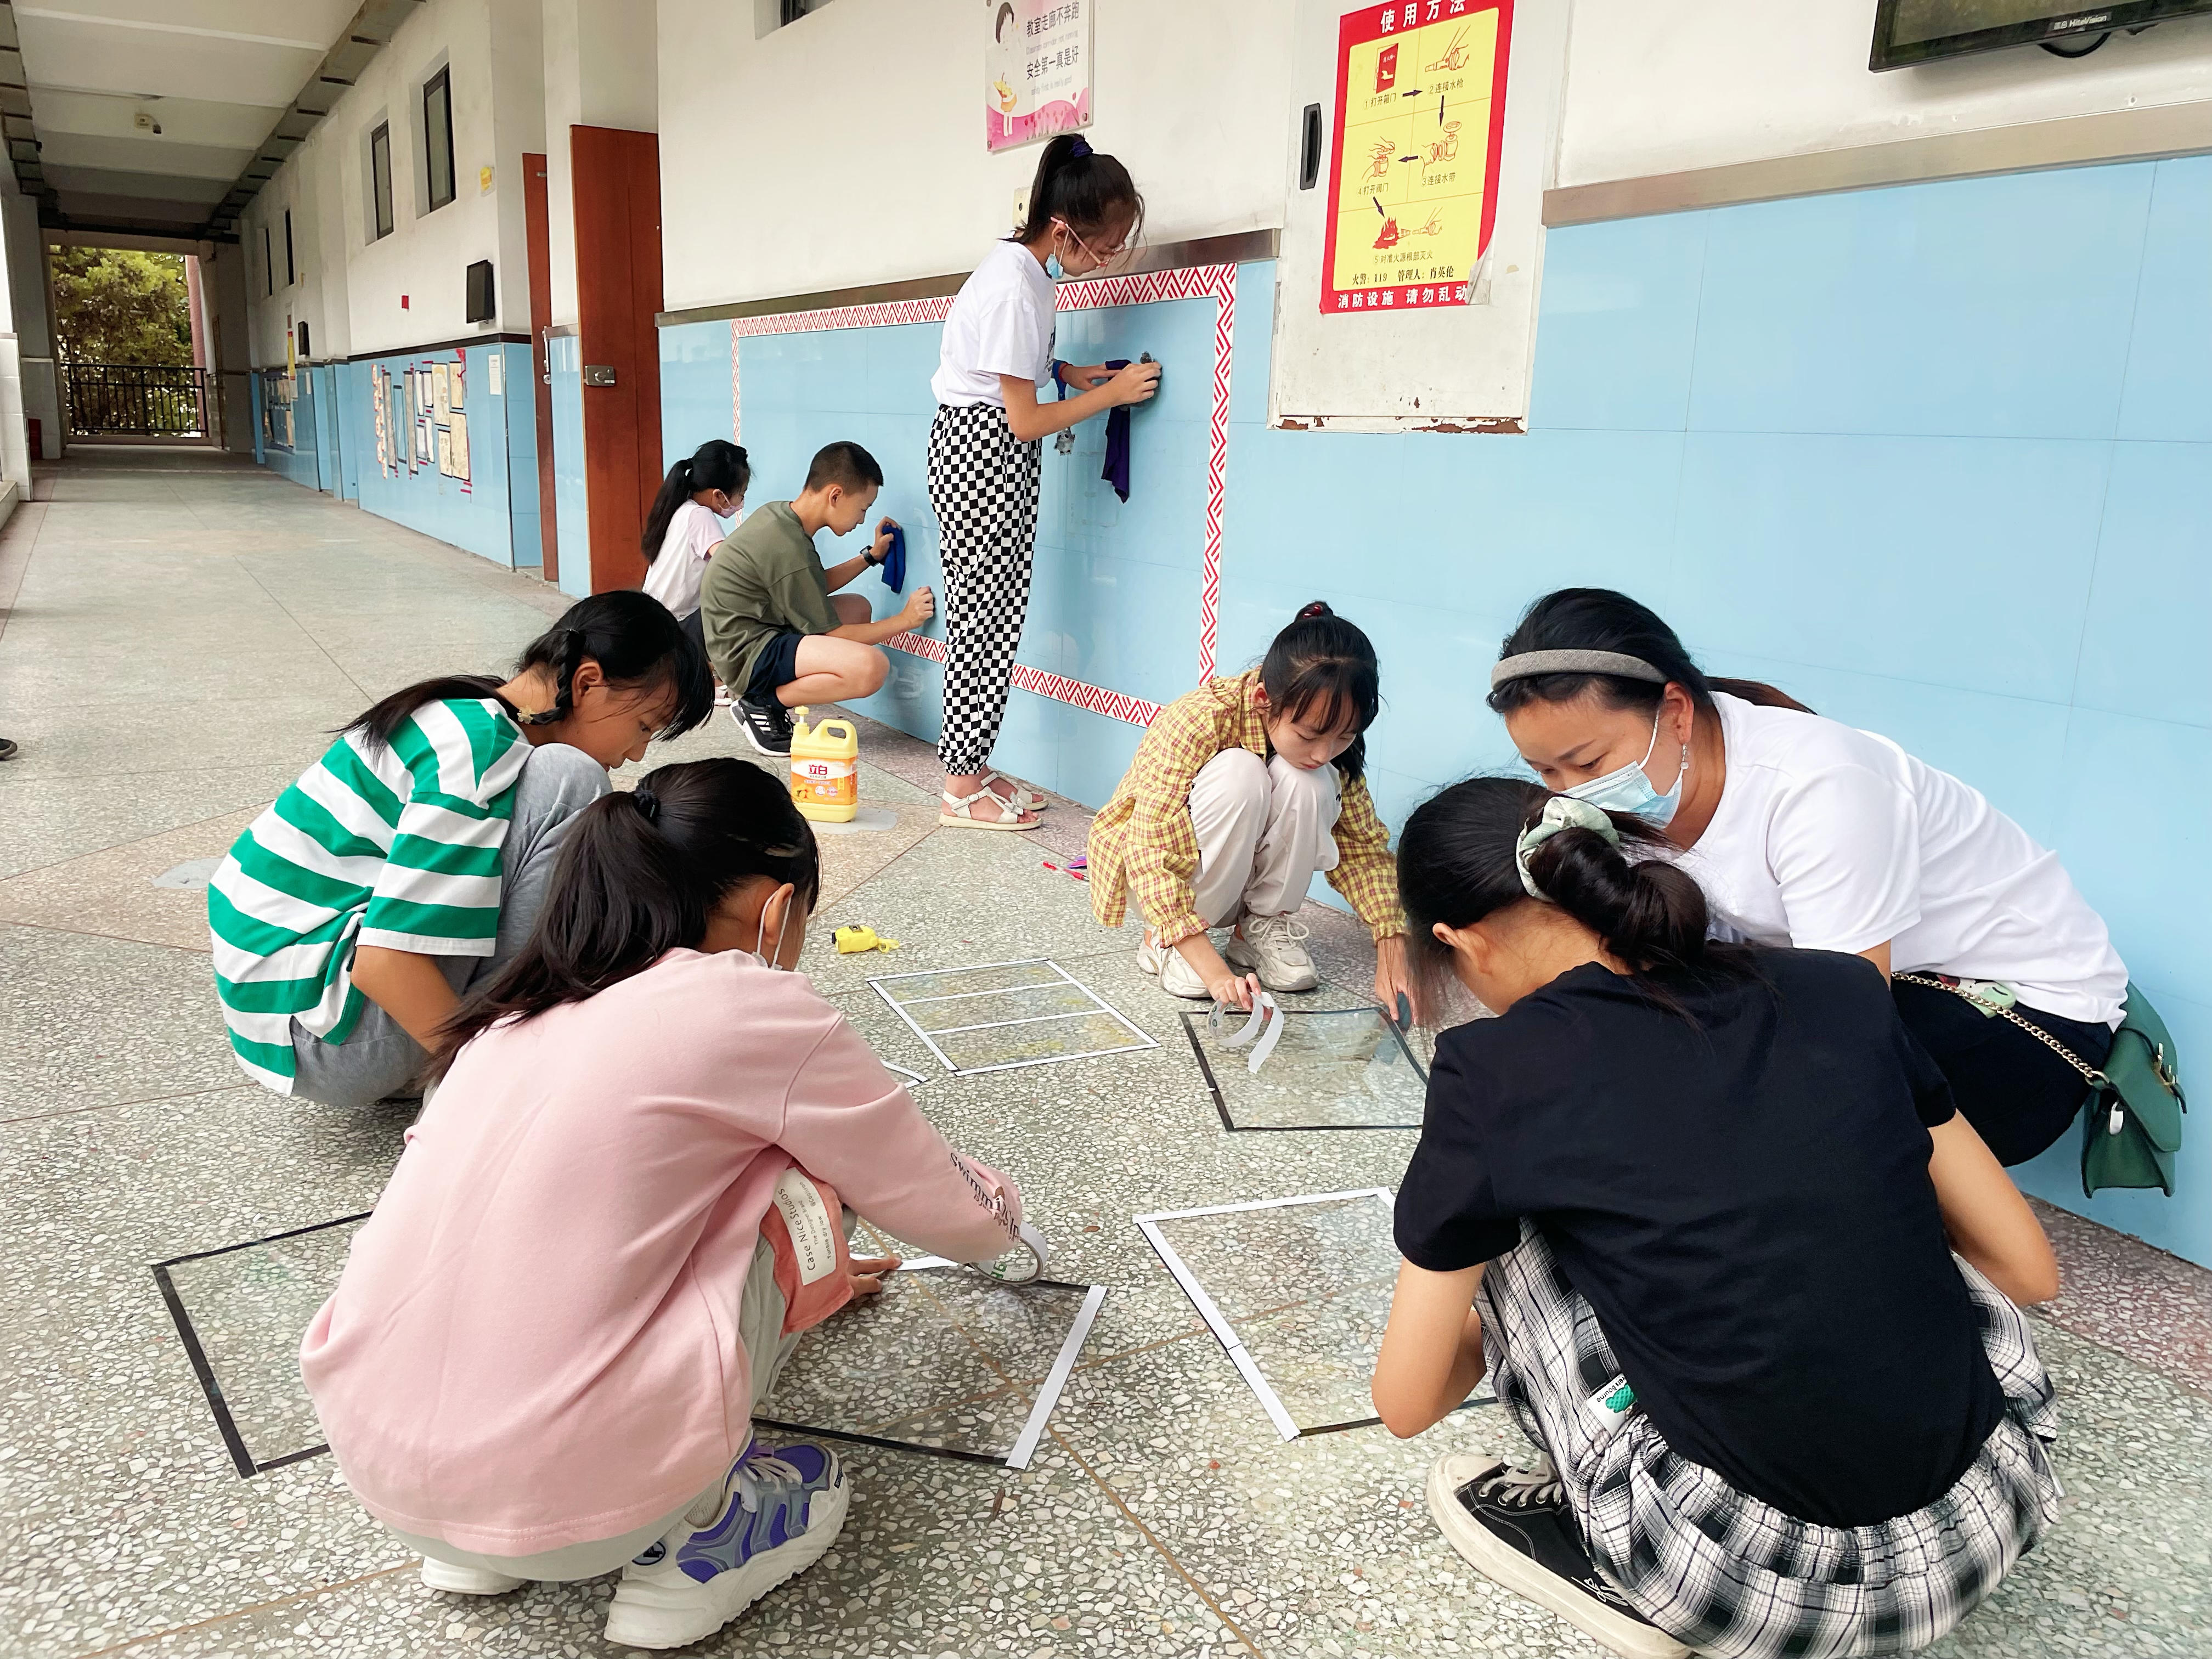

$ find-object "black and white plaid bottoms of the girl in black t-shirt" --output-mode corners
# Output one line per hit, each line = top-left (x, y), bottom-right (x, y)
(1475, 1221), (2059, 1659)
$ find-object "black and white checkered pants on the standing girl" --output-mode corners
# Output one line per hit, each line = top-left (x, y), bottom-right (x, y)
(929, 403), (1044, 776)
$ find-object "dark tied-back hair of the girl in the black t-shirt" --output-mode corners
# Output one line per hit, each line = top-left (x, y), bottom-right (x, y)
(1398, 778), (1747, 1026)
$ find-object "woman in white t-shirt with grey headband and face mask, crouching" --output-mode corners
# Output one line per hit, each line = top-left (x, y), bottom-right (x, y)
(1489, 589), (2128, 1164)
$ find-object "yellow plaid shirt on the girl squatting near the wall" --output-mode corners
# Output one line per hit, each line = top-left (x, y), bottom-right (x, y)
(1088, 668), (1404, 945)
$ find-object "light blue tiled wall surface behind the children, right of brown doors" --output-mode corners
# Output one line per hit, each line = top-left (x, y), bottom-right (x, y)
(662, 157), (2212, 1265)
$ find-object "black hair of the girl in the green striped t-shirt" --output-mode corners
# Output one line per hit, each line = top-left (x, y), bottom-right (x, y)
(338, 591), (714, 748)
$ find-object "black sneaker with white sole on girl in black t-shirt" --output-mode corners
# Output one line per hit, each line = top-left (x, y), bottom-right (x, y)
(1429, 1453), (1690, 1659)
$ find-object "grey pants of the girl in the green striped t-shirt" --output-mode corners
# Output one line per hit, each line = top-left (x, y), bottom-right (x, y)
(292, 743), (613, 1106)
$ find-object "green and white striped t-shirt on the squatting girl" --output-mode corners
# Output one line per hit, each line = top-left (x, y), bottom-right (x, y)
(208, 697), (531, 1095)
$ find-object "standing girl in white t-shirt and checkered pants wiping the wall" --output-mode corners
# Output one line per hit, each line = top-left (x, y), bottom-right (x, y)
(929, 133), (1159, 830)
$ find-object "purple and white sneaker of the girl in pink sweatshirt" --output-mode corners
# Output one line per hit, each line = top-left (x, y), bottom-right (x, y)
(606, 1436), (851, 1648)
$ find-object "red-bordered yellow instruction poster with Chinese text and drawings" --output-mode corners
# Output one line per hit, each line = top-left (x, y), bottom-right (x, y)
(1321, 0), (1513, 314)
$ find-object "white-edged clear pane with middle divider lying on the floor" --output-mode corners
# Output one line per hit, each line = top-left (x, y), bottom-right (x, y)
(870, 958), (1159, 1077)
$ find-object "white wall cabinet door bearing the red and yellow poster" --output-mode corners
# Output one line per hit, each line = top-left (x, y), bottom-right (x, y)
(1267, 0), (1568, 433)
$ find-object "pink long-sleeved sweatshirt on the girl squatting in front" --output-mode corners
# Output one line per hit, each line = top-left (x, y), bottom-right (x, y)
(301, 951), (1020, 1555)
